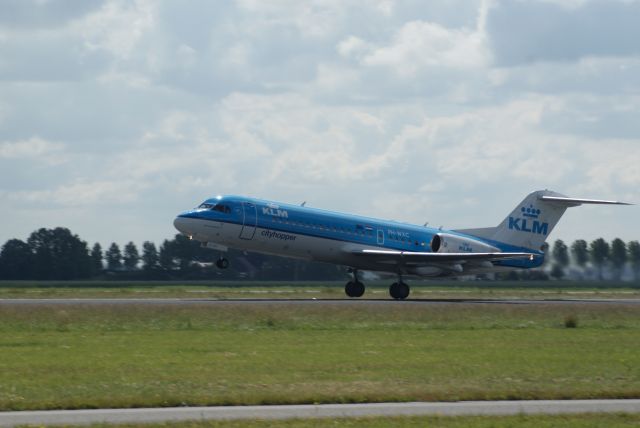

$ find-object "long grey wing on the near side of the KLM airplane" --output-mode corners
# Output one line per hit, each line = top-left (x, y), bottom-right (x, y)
(352, 250), (536, 264)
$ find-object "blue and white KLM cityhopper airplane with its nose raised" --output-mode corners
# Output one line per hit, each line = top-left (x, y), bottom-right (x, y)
(174, 190), (631, 300)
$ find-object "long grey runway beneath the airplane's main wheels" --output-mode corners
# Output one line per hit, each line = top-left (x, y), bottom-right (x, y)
(0, 297), (640, 306)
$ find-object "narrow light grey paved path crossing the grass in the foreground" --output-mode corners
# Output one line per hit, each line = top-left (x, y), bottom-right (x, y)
(0, 400), (640, 427)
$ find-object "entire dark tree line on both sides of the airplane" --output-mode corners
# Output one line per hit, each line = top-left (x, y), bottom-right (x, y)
(0, 227), (640, 281)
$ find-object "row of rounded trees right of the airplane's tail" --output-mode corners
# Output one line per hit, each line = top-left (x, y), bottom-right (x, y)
(551, 238), (640, 280)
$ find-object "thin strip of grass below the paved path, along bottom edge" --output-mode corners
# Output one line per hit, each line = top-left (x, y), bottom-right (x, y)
(70, 414), (640, 428)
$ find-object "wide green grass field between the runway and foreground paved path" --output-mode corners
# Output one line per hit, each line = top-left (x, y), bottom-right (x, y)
(0, 303), (640, 410)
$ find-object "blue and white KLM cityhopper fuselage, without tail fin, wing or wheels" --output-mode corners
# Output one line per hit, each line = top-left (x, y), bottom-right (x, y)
(174, 196), (543, 276)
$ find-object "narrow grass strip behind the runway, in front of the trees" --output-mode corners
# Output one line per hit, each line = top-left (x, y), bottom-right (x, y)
(0, 281), (640, 299)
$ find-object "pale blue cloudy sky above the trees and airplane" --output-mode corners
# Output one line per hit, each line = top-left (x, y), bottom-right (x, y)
(0, 0), (640, 246)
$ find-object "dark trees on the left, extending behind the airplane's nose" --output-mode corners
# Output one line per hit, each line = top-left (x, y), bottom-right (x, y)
(0, 227), (345, 280)
